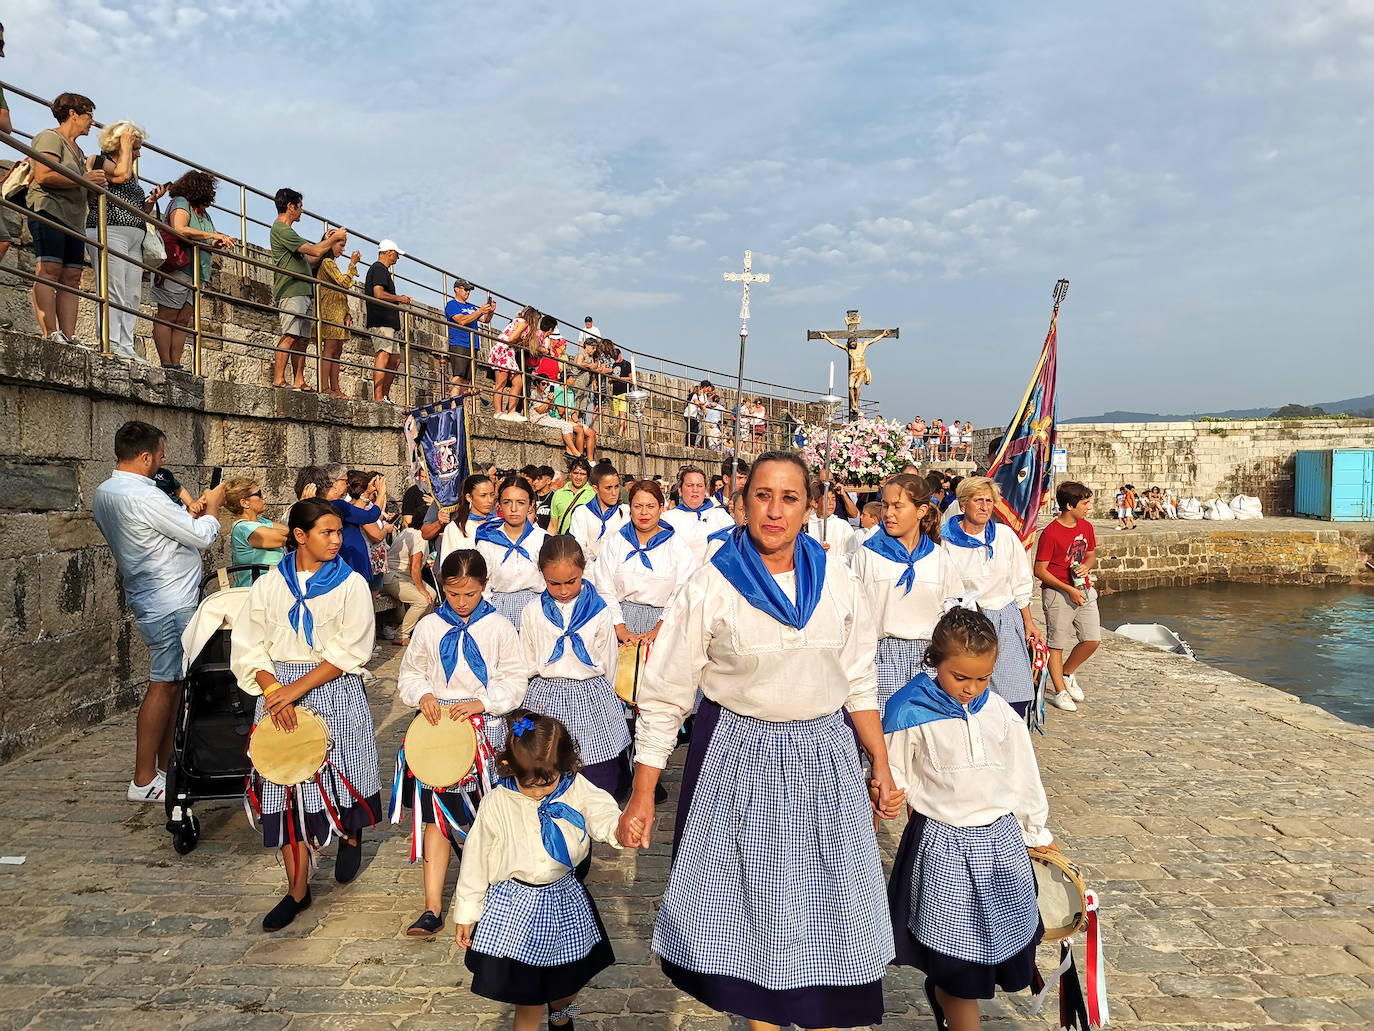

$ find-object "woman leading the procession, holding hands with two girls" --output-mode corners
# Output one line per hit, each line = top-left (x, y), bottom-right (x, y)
(621, 452), (900, 1030)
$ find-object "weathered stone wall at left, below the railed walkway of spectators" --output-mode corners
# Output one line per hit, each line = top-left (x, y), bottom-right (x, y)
(0, 333), (741, 759)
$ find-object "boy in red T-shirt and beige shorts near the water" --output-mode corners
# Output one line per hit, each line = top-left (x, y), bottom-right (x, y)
(1035, 480), (1102, 712)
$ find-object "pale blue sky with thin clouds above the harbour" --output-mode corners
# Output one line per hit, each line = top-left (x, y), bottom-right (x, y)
(0, 0), (1374, 426)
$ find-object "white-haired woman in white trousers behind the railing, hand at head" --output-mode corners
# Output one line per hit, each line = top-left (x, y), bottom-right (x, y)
(87, 121), (166, 359)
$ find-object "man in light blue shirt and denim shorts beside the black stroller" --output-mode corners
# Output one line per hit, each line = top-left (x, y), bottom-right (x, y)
(91, 421), (224, 801)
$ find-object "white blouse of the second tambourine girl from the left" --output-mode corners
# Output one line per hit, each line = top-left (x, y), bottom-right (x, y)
(396, 612), (529, 716)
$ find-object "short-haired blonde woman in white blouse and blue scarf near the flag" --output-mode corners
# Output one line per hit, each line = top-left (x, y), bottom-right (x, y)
(943, 476), (1041, 716)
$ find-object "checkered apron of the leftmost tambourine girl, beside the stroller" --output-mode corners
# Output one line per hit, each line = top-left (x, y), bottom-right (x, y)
(254, 663), (382, 847)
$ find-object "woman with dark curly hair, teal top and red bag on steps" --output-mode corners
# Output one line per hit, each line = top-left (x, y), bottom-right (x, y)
(148, 170), (238, 368)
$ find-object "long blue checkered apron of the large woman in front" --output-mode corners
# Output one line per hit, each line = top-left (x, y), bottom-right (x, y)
(653, 708), (893, 991)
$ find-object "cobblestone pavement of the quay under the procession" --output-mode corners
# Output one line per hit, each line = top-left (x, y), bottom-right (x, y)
(0, 641), (1374, 1031)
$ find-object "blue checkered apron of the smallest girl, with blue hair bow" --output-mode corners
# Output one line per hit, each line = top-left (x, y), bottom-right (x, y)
(473, 870), (602, 966)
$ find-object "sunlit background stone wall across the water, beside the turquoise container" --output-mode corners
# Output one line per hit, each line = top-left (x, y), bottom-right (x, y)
(974, 419), (1374, 516)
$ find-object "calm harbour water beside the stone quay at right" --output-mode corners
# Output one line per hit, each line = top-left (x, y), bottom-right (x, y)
(1090, 583), (1374, 726)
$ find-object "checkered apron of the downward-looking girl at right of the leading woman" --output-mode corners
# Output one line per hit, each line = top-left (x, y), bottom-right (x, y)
(907, 812), (1040, 966)
